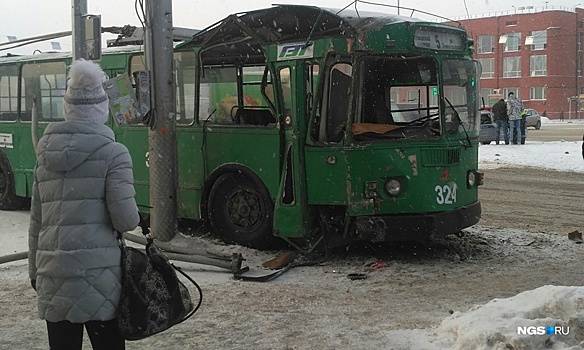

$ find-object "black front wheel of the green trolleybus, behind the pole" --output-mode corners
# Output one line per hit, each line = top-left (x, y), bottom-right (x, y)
(207, 173), (280, 249)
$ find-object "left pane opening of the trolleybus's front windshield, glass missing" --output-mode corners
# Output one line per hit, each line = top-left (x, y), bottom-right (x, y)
(353, 57), (442, 139)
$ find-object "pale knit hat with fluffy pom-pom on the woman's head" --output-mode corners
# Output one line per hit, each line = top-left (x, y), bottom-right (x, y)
(63, 59), (109, 124)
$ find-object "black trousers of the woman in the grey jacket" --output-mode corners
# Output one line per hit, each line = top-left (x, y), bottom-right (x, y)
(47, 319), (126, 350)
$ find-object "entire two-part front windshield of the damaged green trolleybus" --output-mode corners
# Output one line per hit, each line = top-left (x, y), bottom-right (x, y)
(353, 57), (477, 140)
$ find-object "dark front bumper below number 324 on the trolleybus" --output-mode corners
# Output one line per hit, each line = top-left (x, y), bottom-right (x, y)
(353, 201), (481, 242)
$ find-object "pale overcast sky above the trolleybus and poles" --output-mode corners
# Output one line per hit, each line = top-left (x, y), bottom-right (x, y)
(0, 0), (584, 56)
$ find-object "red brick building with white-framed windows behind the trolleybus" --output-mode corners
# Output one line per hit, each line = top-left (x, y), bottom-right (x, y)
(449, 7), (584, 120)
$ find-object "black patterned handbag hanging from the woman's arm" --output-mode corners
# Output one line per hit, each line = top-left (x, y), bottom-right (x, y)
(118, 234), (203, 340)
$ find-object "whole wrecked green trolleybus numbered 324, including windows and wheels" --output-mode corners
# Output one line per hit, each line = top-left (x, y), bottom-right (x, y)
(0, 5), (483, 251)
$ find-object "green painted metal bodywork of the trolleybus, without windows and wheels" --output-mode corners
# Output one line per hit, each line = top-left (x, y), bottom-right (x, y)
(0, 6), (480, 247)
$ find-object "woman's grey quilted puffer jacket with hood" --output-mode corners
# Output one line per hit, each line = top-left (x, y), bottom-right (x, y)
(28, 121), (139, 323)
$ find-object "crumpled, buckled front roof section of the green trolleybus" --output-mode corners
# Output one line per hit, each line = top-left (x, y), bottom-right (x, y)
(177, 5), (436, 61)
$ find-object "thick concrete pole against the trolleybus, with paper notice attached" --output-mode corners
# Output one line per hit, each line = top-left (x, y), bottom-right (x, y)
(144, 0), (177, 241)
